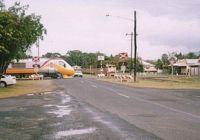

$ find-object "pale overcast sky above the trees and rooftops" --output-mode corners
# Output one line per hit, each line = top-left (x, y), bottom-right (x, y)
(5, 0), (200, 60)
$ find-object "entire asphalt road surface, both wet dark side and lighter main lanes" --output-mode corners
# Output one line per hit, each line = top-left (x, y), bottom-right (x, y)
(0, 78), (200, 140)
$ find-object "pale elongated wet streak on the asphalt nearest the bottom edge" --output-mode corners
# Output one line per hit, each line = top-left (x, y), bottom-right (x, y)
(55, 127), (96, 139)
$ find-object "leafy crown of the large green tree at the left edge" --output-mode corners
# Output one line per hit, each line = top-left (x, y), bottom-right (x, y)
(0, 0), (46, 73)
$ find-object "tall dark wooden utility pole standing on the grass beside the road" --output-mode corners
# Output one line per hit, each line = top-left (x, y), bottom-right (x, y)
(134, 11), (137, 82)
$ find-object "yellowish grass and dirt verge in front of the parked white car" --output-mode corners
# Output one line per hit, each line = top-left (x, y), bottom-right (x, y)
(0, 80), (55, 98)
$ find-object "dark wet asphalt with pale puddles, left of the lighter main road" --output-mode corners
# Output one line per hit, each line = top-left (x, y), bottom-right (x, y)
(0, 90), (160, 140)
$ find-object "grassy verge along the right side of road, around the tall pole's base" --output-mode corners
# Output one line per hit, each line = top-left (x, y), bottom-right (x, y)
(87, 76), (200, 89)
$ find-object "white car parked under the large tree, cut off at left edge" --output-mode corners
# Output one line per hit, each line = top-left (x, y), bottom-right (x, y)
(0, 75), (16, 87)
